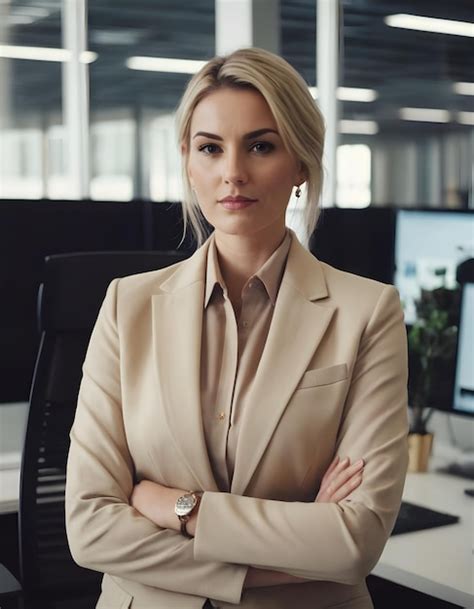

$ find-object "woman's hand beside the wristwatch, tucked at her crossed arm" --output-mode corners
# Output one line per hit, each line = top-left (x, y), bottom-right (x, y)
(130, 480), (186, 531)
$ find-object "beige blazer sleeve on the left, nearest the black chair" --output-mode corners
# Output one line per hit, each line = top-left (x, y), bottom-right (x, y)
(66, 279), (247, 603)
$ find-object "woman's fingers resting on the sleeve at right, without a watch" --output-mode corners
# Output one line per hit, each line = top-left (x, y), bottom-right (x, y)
(315, 456), (365, 503)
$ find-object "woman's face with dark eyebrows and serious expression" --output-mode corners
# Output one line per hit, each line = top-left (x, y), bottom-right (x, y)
(183, 88), (304, 242)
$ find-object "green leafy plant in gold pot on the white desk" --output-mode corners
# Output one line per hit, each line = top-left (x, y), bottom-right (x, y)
(408, 287), (460, 472)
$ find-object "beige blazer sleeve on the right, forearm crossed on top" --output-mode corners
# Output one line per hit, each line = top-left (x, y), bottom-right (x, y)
(194, 286), (408, 584)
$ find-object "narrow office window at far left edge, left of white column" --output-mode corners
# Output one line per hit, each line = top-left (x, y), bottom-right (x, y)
(0, 0), (61, 199)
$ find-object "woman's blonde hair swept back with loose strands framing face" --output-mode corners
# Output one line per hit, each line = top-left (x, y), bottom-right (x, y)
(176, 48), (324, 246)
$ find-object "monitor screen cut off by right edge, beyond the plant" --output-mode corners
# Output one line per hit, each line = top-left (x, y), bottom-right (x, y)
(453, 283), (474, 415)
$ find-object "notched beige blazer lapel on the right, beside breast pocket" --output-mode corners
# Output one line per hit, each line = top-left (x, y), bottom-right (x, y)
(231, 236), (334, 495)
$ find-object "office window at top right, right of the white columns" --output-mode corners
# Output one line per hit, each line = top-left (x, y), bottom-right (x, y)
(339, 0), (474, 208)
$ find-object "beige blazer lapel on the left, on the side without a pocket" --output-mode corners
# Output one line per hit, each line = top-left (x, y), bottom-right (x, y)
(152, 243), (218, 491)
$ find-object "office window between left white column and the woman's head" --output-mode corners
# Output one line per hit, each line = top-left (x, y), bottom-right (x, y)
(88, 0), (215, 200)
